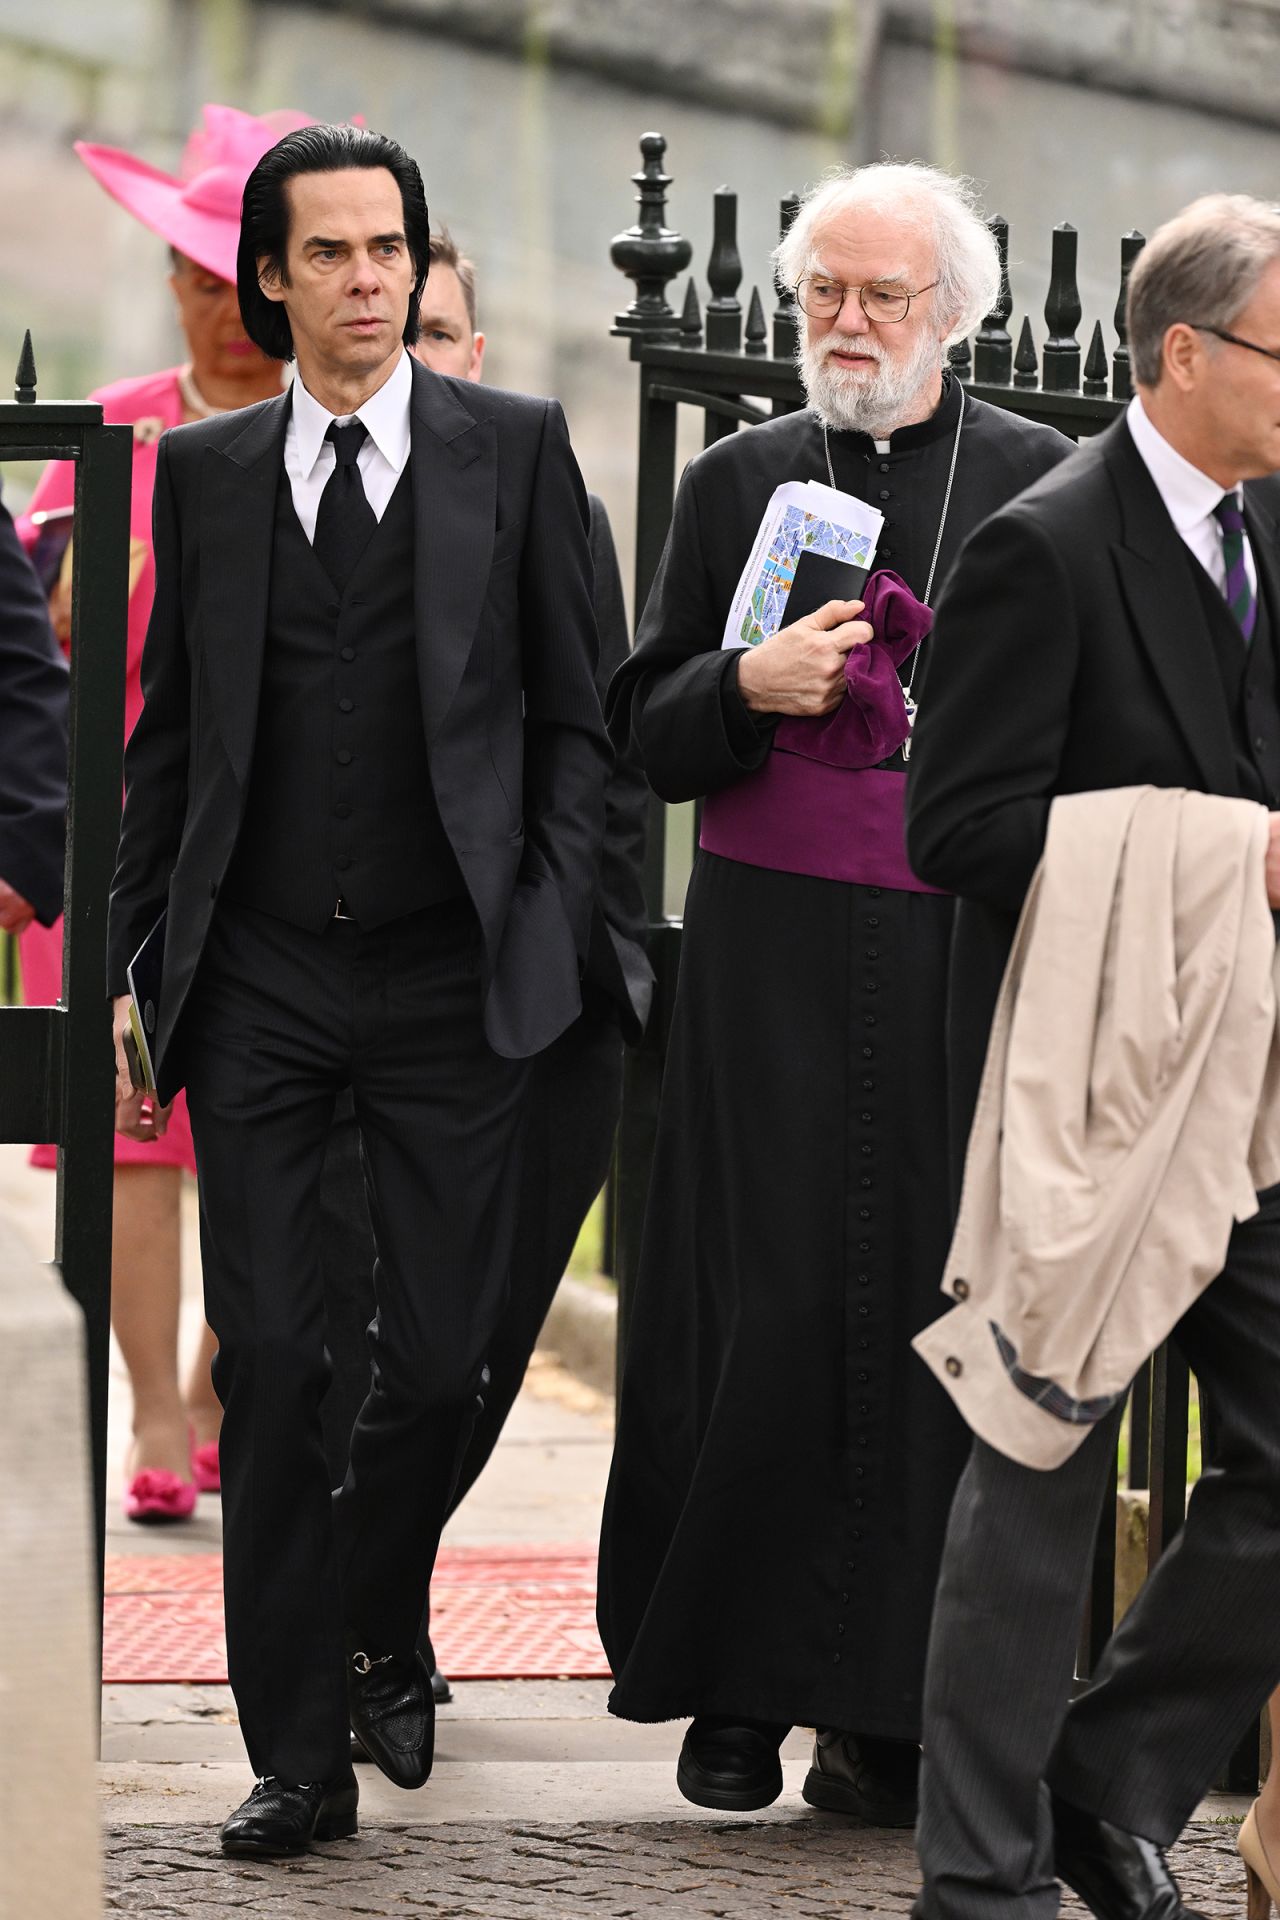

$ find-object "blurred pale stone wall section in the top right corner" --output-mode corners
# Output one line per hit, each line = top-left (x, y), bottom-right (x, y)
(885, 0), (1280, 125)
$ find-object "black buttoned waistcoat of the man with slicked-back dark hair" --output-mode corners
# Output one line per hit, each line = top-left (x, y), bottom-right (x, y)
(223, 467), (464, 933)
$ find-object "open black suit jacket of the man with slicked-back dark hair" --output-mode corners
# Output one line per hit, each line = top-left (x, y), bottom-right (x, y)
(107, 361), (610, 1098)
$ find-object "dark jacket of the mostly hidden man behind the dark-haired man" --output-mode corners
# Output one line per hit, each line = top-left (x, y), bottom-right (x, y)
(585, 493), (652, 1041)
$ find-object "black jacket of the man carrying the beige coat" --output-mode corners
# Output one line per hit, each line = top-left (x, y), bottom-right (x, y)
(908, 420), (1280, 1146)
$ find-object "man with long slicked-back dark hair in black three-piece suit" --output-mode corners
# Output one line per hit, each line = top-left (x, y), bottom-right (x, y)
(109, 127), (608, 1853)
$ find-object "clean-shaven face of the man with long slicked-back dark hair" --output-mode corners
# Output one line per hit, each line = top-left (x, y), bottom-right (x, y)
(259, 167), (416, 380)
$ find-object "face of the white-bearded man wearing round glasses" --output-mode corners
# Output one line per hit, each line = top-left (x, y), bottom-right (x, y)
(800, 205), (950, 436)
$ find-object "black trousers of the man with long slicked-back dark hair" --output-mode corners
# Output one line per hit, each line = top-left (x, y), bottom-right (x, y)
(182, 902), (528, 1780)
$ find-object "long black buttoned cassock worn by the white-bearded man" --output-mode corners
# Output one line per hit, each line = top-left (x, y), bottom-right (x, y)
(599, 380), (1071, 1740)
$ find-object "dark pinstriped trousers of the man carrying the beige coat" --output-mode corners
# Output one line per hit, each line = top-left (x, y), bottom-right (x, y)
(917, 1188), (1280, 1920)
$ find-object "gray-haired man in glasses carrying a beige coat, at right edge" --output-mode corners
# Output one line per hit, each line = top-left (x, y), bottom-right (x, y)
(908, 194), (1280, 1920)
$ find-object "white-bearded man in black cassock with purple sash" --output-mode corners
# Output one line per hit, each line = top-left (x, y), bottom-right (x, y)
(601, 165), (1071, 1826)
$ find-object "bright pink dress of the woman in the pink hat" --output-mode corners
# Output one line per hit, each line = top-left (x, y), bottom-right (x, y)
(17, 367), (196, 1173)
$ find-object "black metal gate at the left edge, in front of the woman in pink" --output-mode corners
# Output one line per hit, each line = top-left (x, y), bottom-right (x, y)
(0, 334), (132, 1620)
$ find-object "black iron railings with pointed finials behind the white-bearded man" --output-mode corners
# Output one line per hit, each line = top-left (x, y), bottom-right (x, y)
(612, 132), (1259, 1791)
